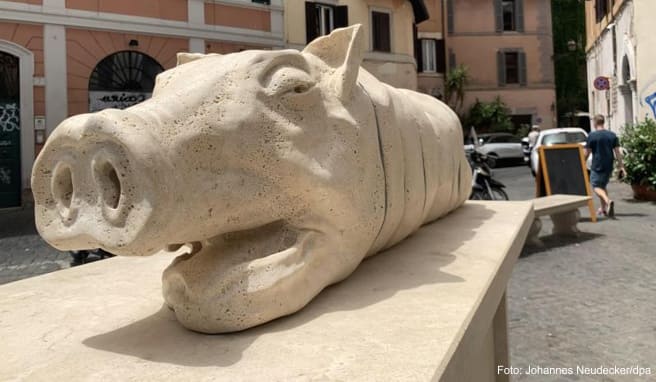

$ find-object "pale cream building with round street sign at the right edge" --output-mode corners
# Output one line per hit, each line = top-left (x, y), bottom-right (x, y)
(586, 0), (656, 133)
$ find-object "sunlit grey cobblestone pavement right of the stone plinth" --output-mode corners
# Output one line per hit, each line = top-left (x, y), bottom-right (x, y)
(495, 167), (656, 381)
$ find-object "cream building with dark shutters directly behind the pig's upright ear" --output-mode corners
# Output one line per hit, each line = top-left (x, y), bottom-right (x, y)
(284, 0), (428, 90)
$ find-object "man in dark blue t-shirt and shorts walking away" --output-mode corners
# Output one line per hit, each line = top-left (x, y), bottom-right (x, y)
(585, 114), (626, 217)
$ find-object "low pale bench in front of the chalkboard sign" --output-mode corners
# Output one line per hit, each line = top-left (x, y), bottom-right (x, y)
(527, 195), (591, 246)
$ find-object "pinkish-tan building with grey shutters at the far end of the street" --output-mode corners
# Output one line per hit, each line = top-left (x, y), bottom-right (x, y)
(444, 0), (557, 129)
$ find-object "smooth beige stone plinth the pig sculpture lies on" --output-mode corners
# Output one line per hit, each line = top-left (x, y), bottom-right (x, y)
(0, 202), (533, 381)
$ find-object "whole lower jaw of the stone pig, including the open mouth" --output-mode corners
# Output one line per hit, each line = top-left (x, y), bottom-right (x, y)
(162, 215), (370, 333)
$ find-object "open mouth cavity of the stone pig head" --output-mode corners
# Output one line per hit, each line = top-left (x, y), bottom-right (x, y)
(162, 220), (321, 318)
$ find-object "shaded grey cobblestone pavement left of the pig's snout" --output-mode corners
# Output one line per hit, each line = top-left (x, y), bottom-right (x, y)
(0, 206), (71, 284)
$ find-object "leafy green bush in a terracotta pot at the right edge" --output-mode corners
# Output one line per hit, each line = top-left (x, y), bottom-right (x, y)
(622, 119), (656, 201)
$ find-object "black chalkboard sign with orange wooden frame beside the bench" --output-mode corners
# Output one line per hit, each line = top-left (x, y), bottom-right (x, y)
(536, 144), (597, 221)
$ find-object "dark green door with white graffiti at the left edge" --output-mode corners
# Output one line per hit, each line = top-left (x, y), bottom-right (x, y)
(0, 52), (21, 208)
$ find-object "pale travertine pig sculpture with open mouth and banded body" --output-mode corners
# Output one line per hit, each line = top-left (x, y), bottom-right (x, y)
(32, 26), (471, 333)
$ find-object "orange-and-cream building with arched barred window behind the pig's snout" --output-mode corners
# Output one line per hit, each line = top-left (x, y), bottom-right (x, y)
(0, 0), (285, 208)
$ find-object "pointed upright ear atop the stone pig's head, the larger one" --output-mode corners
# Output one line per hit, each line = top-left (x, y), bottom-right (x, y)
(303, 24), (366, 100)
